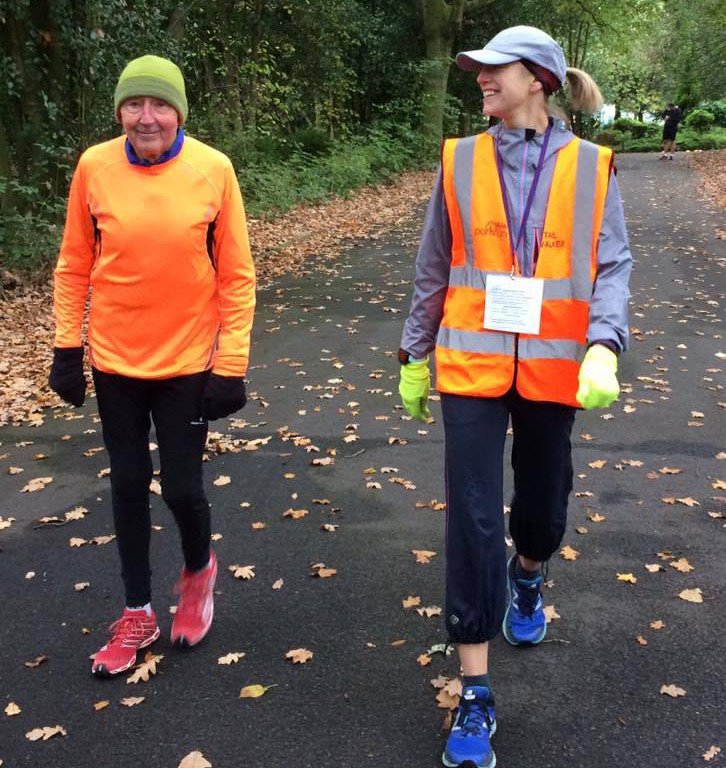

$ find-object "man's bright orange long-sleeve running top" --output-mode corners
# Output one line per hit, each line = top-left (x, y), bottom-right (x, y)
(53, 136), (255, 379)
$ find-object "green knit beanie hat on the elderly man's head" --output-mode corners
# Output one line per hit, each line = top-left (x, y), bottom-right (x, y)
(113, 55), (189, 123)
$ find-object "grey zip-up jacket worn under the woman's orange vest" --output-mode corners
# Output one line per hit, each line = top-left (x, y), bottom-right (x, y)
(401, 120), (633, 359)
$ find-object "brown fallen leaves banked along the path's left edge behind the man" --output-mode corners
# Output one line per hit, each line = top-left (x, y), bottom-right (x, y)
(0, 172), (433, 426)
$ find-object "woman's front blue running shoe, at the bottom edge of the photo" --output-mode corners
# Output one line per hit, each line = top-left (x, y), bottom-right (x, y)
(441, 685), (497, 768)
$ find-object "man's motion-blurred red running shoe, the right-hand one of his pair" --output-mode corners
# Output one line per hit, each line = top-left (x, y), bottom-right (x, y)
(171, 552), (217, 648)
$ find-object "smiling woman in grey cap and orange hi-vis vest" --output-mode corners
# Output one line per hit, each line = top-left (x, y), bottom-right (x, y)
(399, 26), (632, 768)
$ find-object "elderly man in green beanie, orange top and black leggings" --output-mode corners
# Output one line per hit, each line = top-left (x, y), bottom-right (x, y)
(50, 56), (255, 676)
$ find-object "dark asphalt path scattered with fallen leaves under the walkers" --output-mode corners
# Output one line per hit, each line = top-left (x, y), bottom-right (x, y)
(0, 155), (726, 768)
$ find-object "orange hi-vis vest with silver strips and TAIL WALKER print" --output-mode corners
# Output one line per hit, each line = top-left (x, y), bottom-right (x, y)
(436, 133), (612, 407)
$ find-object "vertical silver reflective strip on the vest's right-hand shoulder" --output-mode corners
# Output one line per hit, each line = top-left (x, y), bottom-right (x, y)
(572, 141), (599, 301)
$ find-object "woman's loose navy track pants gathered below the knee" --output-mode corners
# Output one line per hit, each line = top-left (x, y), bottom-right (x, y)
(441, 390), (575, 643)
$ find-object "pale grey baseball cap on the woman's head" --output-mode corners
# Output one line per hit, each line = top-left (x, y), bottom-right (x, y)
(456, 26), (567, 85)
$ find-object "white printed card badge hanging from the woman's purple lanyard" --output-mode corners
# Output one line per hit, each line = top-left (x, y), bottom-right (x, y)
(484, 275), (544, 335)
